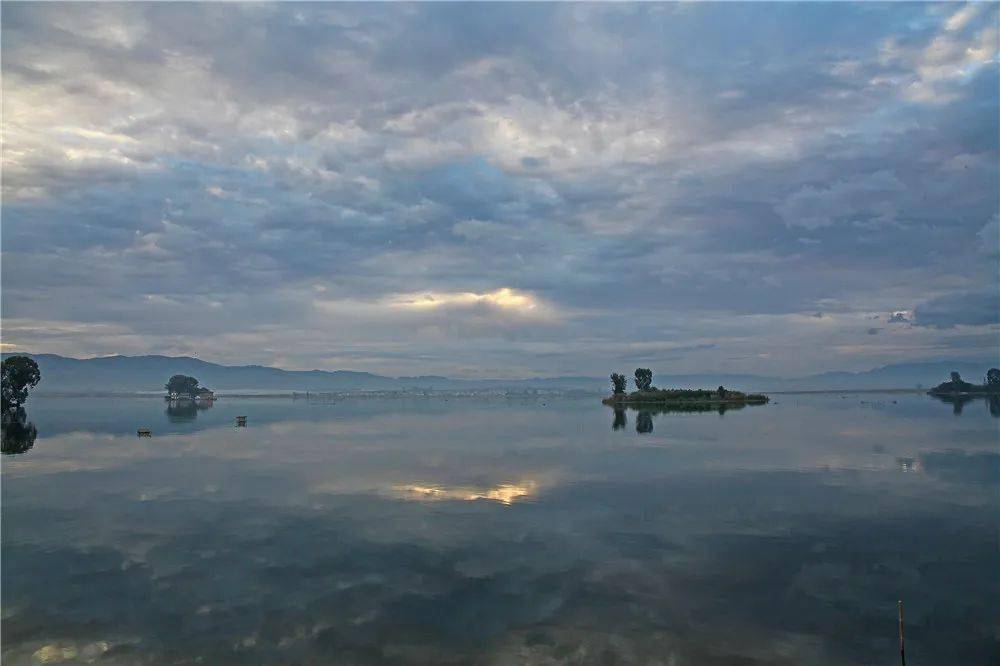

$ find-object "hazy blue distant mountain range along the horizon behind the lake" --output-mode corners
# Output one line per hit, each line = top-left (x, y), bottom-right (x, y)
(3, 353), (997, 393)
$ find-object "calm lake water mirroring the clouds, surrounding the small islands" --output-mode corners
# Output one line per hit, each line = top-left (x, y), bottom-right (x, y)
(2, 394), (1000, 666)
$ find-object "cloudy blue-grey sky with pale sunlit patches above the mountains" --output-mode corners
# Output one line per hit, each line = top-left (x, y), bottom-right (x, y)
(0, 3), (1000, 377)
